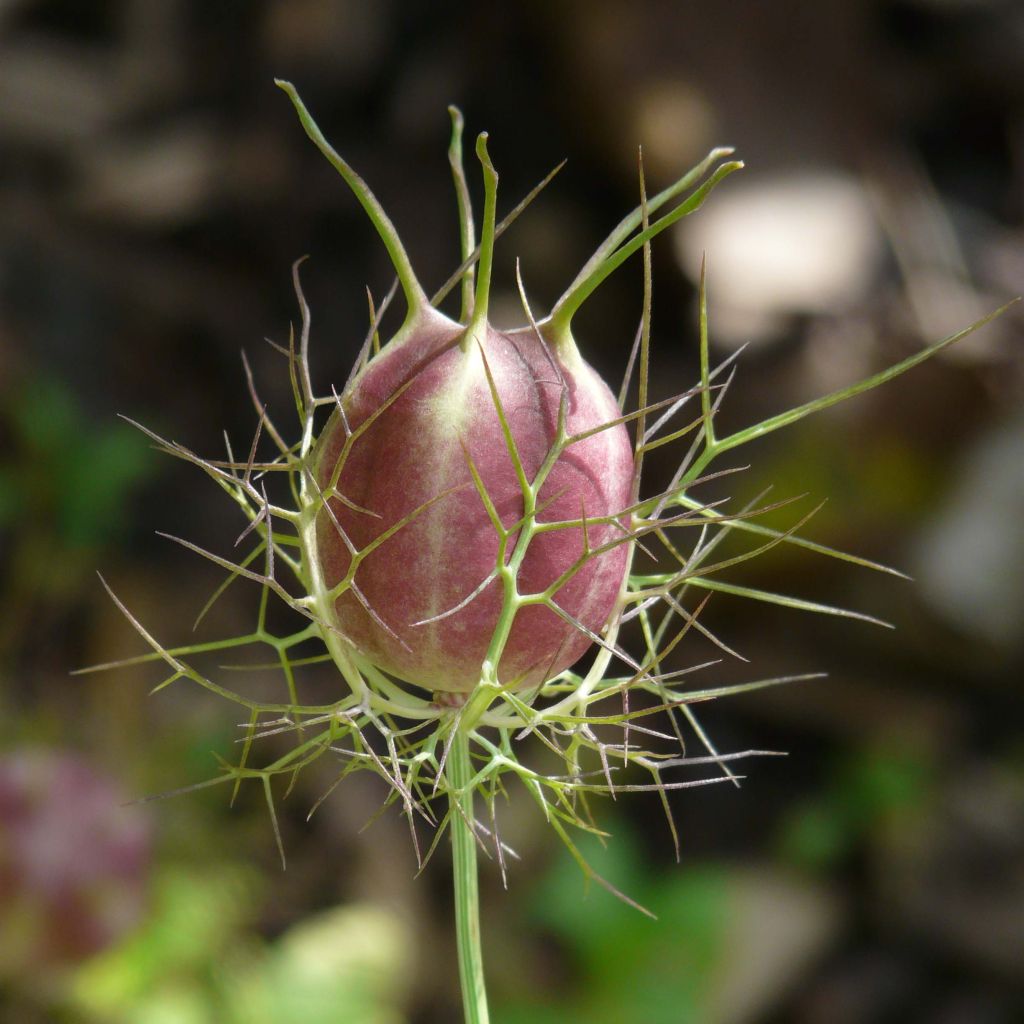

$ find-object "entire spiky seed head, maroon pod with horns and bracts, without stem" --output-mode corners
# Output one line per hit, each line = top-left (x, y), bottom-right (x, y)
(83, 83), (1001, 872)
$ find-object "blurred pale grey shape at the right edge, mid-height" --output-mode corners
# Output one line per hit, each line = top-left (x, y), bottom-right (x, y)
(911, 418), (1024, 651)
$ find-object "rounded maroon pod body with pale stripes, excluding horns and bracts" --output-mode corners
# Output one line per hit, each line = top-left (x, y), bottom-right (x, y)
(315, 310), (633, 692)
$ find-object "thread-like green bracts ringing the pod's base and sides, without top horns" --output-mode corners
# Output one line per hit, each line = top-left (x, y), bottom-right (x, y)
(92, 270), (1015, 853)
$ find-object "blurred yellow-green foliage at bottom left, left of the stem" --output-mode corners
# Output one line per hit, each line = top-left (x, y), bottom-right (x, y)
(70, 865), (412, 1024)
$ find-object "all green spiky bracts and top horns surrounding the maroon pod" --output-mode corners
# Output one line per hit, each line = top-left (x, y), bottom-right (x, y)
(92, 83), (1005, 942)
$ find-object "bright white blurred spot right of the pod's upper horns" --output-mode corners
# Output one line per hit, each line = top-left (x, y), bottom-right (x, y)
(675, 171), (883, 348)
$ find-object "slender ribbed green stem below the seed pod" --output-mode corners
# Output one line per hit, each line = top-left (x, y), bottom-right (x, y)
(446, 727), (490, 1024)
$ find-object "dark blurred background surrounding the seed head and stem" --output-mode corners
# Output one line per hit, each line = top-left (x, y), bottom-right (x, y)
(0, 0), (1024, 1024)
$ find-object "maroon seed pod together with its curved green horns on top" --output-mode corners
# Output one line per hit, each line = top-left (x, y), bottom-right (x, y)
(264, 82), (741, 712)
